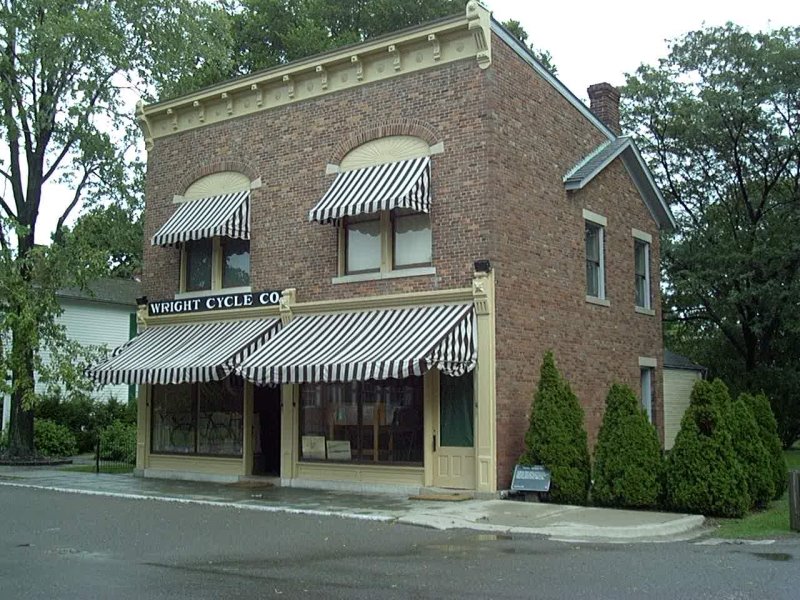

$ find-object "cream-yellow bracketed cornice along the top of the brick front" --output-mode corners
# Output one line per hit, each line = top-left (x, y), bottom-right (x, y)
(136, 0), (492, 150)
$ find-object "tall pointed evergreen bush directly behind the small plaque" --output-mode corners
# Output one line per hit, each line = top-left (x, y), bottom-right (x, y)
(520, 352), (591, 504)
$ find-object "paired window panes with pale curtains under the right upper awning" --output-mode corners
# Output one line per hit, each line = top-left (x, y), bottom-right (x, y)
(342, 210), (433, 275)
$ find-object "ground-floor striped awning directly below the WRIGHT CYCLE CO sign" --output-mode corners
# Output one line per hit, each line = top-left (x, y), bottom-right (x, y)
(88, 319), (280, 384)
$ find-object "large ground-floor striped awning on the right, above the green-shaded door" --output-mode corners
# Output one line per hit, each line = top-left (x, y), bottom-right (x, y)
(237, 304), (476, 384)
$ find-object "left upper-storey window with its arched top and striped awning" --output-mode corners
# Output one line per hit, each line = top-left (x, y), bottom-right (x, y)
(152, 172), (250, 293)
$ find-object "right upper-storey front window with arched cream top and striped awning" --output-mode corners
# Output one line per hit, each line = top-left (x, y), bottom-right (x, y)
(309, 136), (434, 279)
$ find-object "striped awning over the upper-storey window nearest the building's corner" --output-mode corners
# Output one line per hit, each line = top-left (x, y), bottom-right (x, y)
(308, 156), (431, 223)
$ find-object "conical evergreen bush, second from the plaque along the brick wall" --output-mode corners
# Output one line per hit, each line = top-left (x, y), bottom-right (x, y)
(592, 383), (664, 508)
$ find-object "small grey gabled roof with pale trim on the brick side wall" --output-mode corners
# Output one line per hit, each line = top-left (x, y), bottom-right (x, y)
(564, 135), (677, 230)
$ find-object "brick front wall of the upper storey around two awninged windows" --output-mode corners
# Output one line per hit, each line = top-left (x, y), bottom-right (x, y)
(143, 60), (489, 302)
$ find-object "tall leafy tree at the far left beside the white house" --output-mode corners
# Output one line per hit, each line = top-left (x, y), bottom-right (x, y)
(0, 0), (229, 455)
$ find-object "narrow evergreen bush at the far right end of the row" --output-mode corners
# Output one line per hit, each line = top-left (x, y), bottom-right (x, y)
(728, 399), (775, 508)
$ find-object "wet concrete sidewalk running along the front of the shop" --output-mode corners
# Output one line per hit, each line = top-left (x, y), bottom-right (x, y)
(0, 466), (704, 543)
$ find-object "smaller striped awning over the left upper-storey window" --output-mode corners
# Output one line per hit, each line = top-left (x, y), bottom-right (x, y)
(152, 190), (250, 246)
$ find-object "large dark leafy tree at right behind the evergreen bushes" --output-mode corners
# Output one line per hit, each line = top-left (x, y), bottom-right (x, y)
(622, 24), (800, 445)
